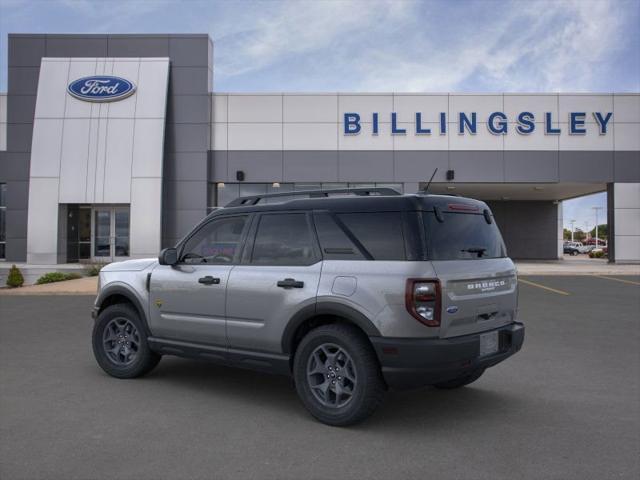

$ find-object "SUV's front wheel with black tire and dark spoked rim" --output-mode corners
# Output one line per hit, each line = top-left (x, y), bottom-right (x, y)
(92, 303), (160, 378)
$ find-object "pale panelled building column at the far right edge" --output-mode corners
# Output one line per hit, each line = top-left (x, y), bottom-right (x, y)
(607, 183), (640, 263)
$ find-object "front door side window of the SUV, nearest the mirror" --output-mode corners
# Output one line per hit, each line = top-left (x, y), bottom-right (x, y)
(181, 216), (247, 265)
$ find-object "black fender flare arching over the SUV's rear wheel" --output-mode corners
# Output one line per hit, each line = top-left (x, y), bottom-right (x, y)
(282, 302), (382, 354)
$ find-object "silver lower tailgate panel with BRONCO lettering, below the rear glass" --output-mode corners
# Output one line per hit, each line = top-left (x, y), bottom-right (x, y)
(432, 258), (518, 337)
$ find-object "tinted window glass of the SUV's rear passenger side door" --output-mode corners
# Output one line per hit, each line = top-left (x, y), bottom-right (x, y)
(251, 213), (317, 265)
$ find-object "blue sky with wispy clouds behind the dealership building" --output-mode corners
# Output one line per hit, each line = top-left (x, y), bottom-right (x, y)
(0, 0), (640, 224)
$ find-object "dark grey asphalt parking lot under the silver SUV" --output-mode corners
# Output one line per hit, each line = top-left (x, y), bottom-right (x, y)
(0, 276), (640, 480)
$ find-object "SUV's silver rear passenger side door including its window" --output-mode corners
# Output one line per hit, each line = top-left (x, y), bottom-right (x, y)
(226, 212), (322, 353)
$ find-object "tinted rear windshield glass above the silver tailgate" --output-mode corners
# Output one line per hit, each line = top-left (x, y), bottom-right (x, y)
(423, 212), (507, 260)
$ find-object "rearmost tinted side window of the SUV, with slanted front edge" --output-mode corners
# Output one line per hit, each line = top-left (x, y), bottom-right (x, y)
(337, 212), (406, 260)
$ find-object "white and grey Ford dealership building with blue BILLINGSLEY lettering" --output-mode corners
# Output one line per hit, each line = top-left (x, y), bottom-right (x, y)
(0, 34), (640, 265)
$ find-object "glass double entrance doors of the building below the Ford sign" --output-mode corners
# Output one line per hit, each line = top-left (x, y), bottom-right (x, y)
(92, 207), (130, 263)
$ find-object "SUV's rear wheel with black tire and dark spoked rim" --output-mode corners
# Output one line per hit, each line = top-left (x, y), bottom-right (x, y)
(293, 324), (385, 426)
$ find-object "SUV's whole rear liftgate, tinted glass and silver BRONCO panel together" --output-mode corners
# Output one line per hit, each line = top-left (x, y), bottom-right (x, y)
(423, 210), (517, 337)
